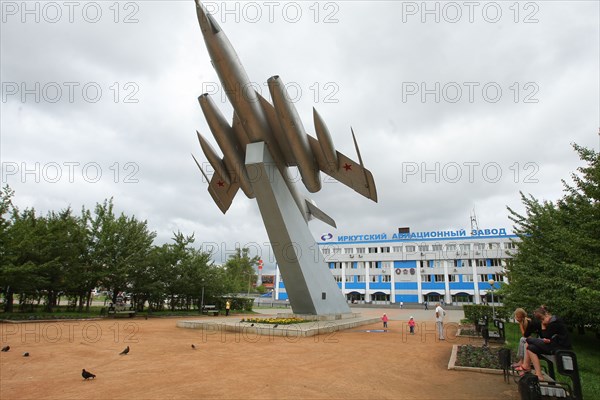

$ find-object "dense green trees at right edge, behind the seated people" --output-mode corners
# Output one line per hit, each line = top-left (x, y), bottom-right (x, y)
(501, 144), (600, 331)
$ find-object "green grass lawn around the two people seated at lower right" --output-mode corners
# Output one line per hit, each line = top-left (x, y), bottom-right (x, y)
(505, 323), (600, 399)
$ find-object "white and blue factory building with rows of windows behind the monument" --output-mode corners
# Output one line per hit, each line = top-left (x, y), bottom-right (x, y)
(275, 229), (518, 305)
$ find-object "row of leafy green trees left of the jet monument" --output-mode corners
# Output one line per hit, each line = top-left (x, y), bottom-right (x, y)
(0, 192), (258, 312)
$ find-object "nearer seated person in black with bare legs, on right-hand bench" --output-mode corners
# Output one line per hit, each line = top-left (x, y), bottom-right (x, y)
(527, 307), (571, 381)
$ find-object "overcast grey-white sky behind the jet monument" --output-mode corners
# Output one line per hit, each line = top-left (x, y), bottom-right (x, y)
(0, 0), (600, 268)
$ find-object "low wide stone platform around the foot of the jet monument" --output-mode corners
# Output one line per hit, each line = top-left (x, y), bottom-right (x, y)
(177, 313), (380, 338)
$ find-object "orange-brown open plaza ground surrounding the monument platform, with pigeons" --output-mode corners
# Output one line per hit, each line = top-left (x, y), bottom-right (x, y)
(0, 308), (518, 400)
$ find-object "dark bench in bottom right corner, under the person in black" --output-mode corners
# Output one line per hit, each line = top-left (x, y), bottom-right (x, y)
(540, 350), (583, 400)
